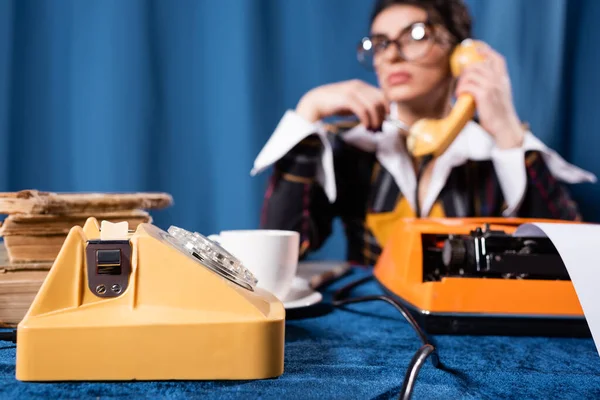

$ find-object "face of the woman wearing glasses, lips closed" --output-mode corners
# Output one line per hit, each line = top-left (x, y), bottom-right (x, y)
(371, 5), (450, 103)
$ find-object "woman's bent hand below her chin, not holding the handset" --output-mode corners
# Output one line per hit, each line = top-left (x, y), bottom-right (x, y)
(296, 80), (390, 130)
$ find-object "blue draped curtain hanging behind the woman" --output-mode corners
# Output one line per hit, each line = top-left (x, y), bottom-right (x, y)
(0, 0), (600, 257)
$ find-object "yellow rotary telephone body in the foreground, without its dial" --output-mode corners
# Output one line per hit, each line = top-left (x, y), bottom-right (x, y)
(16, 218), (285, 381)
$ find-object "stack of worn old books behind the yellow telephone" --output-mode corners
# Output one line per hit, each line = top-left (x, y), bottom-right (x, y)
(0, 190), (173, 326)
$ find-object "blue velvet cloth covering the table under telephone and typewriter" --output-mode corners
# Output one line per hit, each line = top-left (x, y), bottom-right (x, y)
(0, 271), (600, 399)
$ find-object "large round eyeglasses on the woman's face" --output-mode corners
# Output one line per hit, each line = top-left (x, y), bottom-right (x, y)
(357, 21), (437, 69)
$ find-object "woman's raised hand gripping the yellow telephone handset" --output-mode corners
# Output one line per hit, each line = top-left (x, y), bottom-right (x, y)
(456, 46), (524, 149)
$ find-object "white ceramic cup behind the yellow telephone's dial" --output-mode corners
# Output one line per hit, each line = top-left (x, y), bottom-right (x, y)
(209, 229), (300, 301)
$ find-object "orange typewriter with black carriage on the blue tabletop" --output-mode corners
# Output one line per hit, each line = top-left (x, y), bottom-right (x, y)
(374, 218), (590, 336)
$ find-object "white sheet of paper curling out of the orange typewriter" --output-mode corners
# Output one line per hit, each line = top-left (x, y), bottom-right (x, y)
(514, 223), (600, 354)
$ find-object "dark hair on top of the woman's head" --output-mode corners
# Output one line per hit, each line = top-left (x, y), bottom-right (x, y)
(371, 0), (472, 43)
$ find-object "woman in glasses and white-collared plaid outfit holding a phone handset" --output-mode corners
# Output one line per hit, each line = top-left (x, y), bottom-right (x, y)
(254, 0), (595, 265)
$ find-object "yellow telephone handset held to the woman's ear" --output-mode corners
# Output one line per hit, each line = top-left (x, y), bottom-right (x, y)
(406, 39), (484, 158)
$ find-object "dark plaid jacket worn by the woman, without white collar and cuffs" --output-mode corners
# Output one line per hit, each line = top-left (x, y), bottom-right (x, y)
(261, 123), (581, 265)
